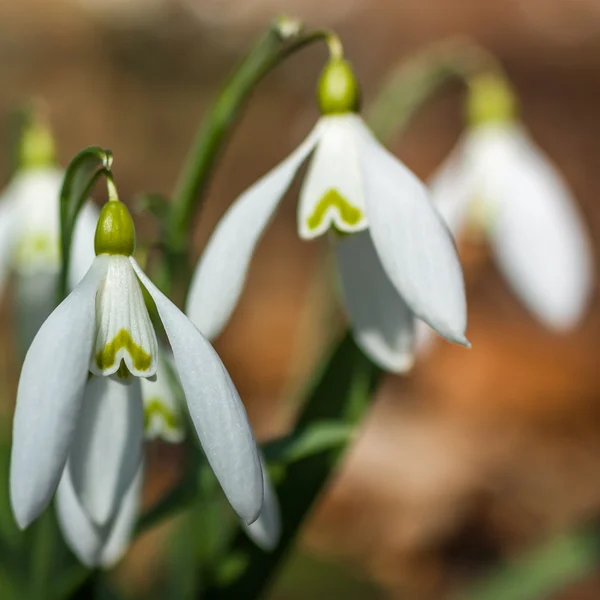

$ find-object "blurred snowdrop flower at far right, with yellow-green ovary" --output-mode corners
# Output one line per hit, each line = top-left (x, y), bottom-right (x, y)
(430, 75), (593, 331)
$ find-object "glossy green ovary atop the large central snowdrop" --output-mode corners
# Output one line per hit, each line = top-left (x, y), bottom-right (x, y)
(317, 58), (360, 115)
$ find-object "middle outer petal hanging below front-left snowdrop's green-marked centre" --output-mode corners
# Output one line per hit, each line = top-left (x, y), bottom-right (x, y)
(68, 377), (144, 525)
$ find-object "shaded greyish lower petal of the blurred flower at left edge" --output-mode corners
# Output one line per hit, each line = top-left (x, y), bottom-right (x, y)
(12, 272), (58, 356)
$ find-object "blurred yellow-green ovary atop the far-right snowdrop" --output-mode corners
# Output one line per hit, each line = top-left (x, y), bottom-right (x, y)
(467, 73), (517, 127)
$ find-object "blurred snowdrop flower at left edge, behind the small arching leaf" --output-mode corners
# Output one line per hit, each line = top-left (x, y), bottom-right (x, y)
(0, 123), (98, 350)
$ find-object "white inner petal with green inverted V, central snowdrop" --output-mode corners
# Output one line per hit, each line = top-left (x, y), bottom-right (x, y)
(298, 113), (368, 239)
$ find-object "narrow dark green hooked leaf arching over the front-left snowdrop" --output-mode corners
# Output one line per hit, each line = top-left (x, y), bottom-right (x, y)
(59, 146), (113, 299)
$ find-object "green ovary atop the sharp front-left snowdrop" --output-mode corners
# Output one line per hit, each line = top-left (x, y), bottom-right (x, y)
(94, 200), (135, 256)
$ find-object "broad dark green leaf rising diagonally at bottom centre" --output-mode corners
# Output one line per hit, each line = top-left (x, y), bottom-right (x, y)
(202, 333), (380, 600)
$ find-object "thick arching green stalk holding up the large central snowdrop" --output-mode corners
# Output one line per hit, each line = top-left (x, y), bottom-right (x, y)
(166, 19), (337, 263)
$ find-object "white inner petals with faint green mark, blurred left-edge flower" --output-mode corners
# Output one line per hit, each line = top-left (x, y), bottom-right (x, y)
(11, 169), (63, 273)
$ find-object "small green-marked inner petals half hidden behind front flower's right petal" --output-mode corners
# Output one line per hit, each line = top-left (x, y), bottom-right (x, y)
(140, 349), (185, 444)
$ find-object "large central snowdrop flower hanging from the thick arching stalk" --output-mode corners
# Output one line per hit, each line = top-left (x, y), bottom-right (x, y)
(186, 56), (468, 371)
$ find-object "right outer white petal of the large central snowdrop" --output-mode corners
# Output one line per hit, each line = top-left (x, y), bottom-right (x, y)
(356, 120), (468, 345)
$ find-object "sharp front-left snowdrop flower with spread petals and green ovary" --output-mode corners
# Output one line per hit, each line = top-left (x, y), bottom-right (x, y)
(10, 178), (263, 528)
